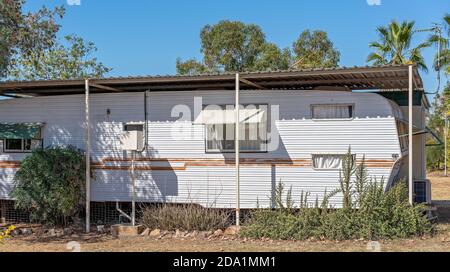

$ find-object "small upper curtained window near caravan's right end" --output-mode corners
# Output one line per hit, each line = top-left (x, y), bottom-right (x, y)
(311, 104), (354, 119)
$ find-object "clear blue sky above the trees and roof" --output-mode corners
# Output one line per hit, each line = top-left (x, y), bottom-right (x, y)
(25, 0), (450, 100)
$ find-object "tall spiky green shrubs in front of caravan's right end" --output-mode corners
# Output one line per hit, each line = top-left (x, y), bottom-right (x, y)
(241, 150), (434, 240)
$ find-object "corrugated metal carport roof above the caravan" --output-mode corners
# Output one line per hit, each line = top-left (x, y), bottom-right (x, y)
(0, 65), (423, 95)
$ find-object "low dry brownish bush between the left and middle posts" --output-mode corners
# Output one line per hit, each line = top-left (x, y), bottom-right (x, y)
(141, 204), (231, 231)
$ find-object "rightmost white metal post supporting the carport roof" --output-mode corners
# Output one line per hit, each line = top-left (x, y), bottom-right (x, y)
(408, 65), (414, 205)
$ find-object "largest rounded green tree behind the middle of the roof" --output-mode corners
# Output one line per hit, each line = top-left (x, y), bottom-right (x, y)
(177, 20), (290, 75)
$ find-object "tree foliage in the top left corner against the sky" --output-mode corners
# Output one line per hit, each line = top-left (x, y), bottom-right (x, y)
(0, 0), (64, 78)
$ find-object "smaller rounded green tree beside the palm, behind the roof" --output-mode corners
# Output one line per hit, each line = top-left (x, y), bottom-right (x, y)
(293, 30), (340, 69)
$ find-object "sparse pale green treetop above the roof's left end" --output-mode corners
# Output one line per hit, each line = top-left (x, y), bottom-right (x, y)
(9, 35), (111, 80)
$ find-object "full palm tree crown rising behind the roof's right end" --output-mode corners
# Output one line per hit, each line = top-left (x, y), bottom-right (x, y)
(367, 20), (431, 71)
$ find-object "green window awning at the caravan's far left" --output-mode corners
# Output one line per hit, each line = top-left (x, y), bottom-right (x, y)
(0, 123), (43, 139)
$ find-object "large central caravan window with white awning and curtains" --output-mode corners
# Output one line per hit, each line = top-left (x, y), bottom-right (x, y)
(204, 105), (267, 152)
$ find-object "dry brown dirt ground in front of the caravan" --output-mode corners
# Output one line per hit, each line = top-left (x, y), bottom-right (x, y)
(0, 173), (450, 252)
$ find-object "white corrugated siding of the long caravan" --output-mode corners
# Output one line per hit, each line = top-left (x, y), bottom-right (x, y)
(0, 90), (400, 208)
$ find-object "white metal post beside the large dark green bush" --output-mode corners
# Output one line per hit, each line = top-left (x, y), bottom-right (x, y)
(85, 79), (91, 233)
